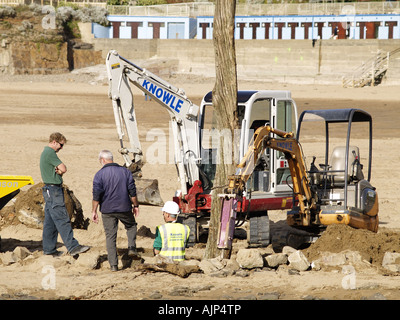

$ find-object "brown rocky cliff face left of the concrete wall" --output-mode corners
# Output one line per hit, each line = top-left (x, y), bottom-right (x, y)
(0, 8), (104, 74)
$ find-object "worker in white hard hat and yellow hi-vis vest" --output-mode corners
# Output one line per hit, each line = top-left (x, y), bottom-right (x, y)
(153, 201), (190, 261)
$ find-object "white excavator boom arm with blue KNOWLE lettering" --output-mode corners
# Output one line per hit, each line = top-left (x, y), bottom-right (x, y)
(106, 50), (200, 195)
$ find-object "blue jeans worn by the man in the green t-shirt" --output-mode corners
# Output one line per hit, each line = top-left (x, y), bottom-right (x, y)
(42, 185), (79, 254)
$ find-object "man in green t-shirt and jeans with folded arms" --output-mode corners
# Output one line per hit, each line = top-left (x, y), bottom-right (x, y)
(40, 132), (89, 256)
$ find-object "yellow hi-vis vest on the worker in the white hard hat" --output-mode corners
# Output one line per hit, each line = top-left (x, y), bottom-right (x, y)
(157, 223), (190, 261)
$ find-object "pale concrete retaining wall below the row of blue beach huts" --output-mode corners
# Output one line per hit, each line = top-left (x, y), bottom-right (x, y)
(93, 39), (400, 84)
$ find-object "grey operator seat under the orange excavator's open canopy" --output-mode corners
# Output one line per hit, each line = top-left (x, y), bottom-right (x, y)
(330, 146), (364, 187)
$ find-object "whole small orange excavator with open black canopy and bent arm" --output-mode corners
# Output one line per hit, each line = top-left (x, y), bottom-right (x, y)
(218, 109), (379, 251)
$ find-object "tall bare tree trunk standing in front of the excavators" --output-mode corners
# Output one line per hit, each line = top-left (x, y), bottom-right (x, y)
(204, 0), (238, 259)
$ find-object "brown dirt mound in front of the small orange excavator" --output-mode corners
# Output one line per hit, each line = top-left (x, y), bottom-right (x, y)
(304, 224), (400, 266)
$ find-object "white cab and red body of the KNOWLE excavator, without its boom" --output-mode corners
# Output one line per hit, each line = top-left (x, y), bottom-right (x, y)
(197, 90), (298, 246)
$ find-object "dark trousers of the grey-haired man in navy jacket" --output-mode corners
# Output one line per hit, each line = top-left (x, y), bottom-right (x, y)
(102, 212), (137, 266)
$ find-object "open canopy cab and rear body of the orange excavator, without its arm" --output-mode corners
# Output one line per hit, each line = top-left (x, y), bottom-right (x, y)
(294, 109), (379, 232)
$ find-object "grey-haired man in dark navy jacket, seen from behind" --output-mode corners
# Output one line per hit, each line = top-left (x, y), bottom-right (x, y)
(92, 150), (139, 271)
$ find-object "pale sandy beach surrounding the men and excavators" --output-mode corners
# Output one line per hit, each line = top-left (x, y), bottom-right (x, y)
(0, 69), (400, 300)
